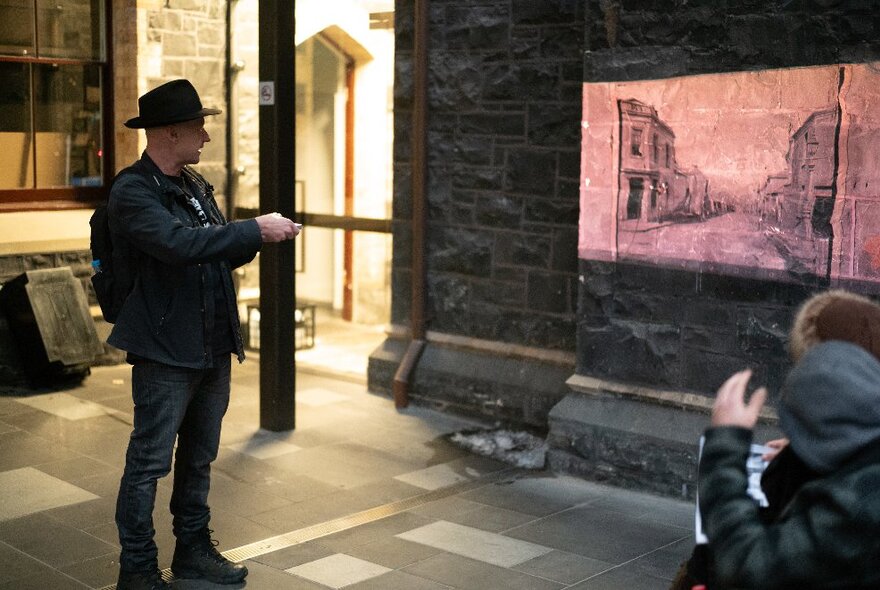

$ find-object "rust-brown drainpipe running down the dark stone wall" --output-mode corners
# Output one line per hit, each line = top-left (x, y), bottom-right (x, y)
(392, 0), (428, 408)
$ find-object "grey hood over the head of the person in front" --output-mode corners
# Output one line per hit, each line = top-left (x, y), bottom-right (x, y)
(779, 340), (880, 473)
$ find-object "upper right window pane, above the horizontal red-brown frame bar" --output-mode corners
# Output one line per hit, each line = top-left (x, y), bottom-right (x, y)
(36, 0), (104, 59)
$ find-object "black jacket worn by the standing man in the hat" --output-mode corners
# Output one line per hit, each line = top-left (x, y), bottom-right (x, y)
(107, 153), (262, 368)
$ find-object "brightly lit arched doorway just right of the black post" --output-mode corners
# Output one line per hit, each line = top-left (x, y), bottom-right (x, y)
(295, 32), (391, 378)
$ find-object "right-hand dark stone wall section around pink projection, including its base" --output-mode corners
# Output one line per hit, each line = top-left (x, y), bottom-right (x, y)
(548, 0), (880, 497)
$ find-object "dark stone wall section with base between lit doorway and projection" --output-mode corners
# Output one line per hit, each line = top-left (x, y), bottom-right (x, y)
(369, 0), (586, 428)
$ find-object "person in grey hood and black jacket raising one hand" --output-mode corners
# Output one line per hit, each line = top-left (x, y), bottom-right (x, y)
(699, 340), (880, 590)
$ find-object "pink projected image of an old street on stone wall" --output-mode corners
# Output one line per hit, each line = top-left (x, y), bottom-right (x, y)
(579, 63), (880, 282)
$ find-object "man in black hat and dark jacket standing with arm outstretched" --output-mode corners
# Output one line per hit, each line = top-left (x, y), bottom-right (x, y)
(107, 80), (299, 590)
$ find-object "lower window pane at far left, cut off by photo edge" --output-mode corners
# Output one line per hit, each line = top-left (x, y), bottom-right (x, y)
(0, 62), (34, 189)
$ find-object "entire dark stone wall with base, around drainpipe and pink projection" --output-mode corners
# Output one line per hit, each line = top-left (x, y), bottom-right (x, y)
(384, 0), (880, 496)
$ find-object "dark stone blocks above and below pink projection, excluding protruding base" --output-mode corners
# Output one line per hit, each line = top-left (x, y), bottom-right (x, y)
(577, 0), (880, 394)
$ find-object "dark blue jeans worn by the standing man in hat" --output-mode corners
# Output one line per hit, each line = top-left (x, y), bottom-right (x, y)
(116, 355), (231, 571)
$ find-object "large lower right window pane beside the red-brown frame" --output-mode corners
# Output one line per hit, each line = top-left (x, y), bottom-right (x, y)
(33, 65), (103, 188)
